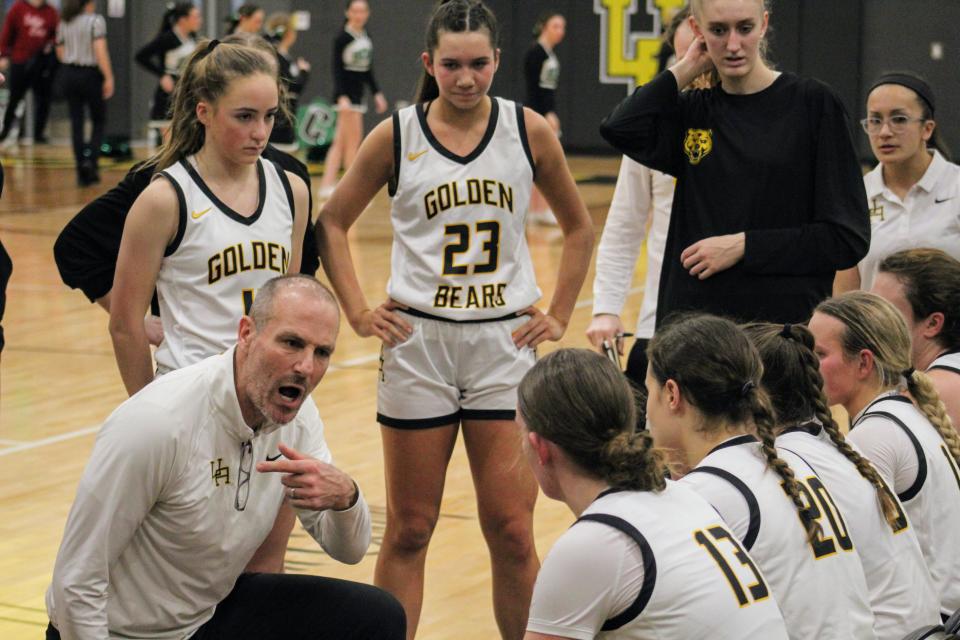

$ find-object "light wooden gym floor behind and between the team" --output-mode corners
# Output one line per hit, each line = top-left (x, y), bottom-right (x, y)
(0, 146), (643, 640)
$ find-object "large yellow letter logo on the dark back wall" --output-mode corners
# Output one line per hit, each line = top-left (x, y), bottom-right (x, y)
(593, 0), (687, 93)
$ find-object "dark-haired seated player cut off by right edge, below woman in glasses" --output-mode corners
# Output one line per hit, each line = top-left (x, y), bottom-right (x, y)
(871, 249), (960, 429)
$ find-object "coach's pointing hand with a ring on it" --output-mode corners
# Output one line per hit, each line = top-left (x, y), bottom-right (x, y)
(257, 444), (358, 511)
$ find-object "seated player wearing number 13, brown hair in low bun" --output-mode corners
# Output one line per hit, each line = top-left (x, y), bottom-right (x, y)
(517, 349), (787, 640)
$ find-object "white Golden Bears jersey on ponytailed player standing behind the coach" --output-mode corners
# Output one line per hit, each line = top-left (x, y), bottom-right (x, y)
(155, 158), (294, 371)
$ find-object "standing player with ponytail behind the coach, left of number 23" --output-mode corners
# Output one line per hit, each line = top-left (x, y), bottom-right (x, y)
(110, 36), (310, 571)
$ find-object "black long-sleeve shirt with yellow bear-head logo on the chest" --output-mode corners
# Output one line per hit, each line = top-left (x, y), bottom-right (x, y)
(600, 71), (870, 324)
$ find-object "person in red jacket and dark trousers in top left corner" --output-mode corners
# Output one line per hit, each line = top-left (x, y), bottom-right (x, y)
(0, 0), (60, 143)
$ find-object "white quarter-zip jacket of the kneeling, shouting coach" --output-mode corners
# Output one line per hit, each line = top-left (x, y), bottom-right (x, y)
(46, 349), (370, 640)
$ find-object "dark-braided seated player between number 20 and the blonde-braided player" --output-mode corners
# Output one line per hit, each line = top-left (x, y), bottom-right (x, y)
(744, 324), (939, 640)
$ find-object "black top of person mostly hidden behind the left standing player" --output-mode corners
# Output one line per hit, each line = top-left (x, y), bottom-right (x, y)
(53, 145), (320, 302)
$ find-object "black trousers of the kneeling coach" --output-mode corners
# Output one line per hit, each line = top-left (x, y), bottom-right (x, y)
(47, 573), (407, 640)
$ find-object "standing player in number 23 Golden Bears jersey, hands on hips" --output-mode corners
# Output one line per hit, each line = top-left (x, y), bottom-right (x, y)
(318, 0), (593, 638)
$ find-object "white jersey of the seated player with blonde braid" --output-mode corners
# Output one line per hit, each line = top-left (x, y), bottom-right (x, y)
(851, 395), (960, 615)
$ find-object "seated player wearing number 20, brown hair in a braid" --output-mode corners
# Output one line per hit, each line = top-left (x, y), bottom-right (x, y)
(646, 315), (876, 640)
